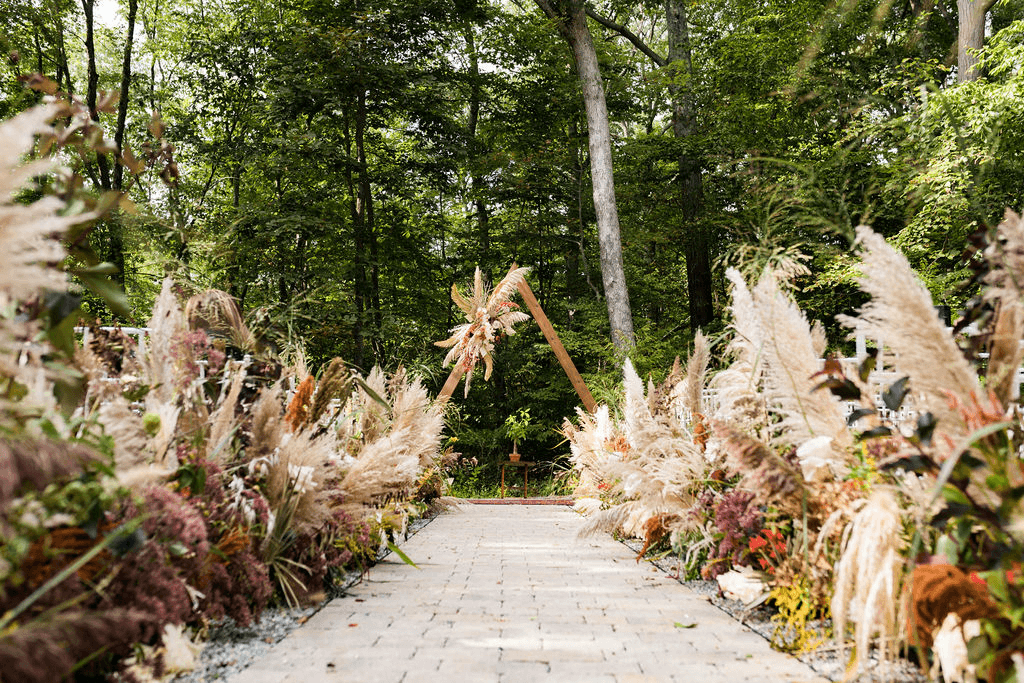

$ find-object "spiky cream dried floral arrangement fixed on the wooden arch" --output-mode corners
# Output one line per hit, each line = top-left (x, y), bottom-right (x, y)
(434, 265), (529, 395)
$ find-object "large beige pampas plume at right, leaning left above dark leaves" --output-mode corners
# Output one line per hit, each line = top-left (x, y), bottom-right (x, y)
(837, 225), (979, 436)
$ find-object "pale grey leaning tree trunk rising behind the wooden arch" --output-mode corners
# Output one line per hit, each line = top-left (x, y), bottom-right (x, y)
(535, 0), (636, 353)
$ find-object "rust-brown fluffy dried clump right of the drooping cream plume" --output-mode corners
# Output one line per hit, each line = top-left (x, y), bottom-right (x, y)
(910, 564), (998, 647)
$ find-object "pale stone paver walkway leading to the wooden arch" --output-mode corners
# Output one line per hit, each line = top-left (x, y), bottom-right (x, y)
(232, 505), (824, 683)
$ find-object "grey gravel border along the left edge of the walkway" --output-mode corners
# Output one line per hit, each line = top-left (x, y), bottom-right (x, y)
(171, 514), (437, 683)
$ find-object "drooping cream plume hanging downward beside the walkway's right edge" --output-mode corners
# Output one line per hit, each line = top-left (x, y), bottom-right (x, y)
(831, 487), (904, 667)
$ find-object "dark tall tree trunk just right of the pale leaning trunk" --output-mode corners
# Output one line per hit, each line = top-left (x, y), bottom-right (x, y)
(665, 0), (715, 330)
